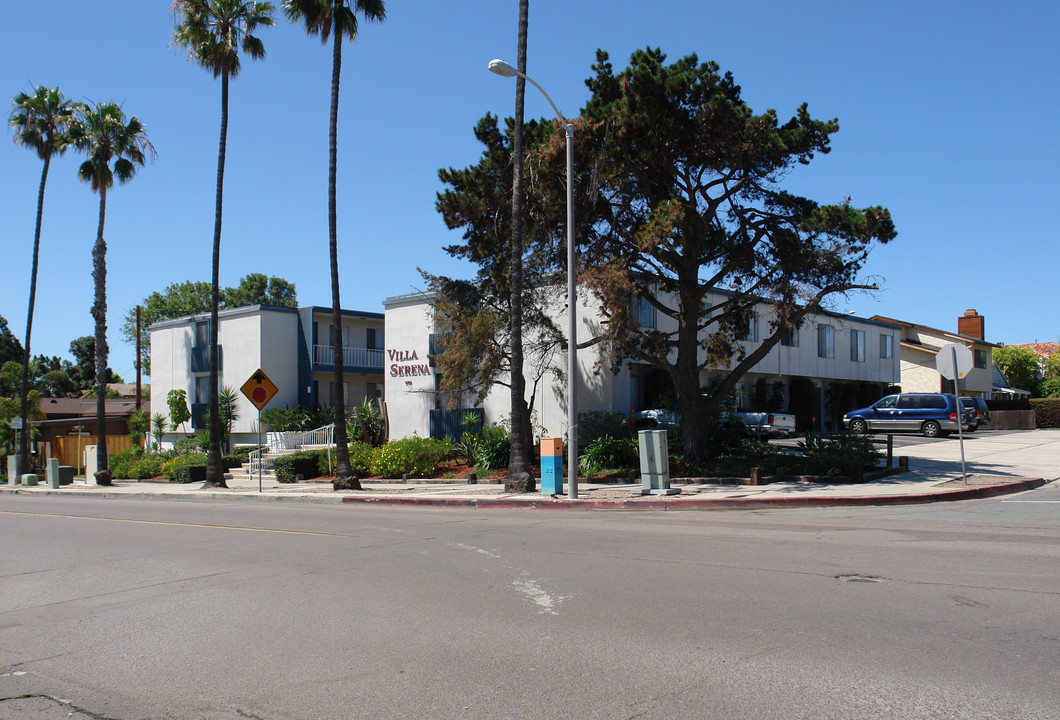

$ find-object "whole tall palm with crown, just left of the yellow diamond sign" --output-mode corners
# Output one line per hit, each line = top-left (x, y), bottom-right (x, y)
(173, 0), (276, 488)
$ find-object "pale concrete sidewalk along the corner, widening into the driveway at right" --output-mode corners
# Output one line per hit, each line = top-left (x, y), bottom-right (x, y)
(8, 431), (1060, 510)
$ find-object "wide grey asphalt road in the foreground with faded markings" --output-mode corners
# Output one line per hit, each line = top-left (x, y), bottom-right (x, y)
(0, 484), (1060, 720)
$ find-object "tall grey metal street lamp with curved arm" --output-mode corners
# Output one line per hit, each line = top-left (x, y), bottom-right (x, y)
(488, 59), (578, 499)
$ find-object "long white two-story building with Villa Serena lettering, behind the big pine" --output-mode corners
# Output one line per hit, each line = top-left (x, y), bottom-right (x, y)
(384, 293), (900, 437)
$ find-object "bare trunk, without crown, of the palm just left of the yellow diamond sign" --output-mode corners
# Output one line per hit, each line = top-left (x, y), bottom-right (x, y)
(202, 70), (228, 488)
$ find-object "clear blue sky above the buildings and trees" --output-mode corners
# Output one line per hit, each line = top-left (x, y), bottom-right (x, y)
(0, 0), (1060, 381)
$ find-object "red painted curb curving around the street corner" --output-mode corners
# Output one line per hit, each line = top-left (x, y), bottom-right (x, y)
(342, 477), (1045, 511)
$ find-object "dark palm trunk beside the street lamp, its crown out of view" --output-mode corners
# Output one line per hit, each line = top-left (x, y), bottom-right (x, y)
(505, 0), (536, 492)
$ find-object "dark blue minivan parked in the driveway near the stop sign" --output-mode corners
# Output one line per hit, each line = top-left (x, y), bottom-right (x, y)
(843, 392), (973, 438)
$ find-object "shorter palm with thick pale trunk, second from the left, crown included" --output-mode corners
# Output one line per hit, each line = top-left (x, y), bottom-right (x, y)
(70, 102), (155, 485)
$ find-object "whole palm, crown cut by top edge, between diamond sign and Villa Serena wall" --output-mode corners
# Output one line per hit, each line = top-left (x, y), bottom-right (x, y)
(283, 0), (387, 490)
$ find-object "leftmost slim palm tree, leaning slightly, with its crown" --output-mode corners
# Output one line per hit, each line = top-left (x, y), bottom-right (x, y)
(8, 87), (76, 479)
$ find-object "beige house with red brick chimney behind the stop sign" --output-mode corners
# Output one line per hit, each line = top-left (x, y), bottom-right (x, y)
(872, 310), (997, 398)
